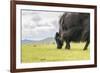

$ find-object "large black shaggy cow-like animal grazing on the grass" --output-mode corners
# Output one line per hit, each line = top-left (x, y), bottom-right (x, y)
(55, 12), (90, 50)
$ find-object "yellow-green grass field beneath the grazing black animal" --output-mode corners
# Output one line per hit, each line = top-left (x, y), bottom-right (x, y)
(21, 43), (90, 63)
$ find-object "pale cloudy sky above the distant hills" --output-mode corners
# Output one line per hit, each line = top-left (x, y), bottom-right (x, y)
(21, 10), (63, 41)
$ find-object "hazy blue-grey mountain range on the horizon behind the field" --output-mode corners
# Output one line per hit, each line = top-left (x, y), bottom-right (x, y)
(22, 38), (55, 44)
